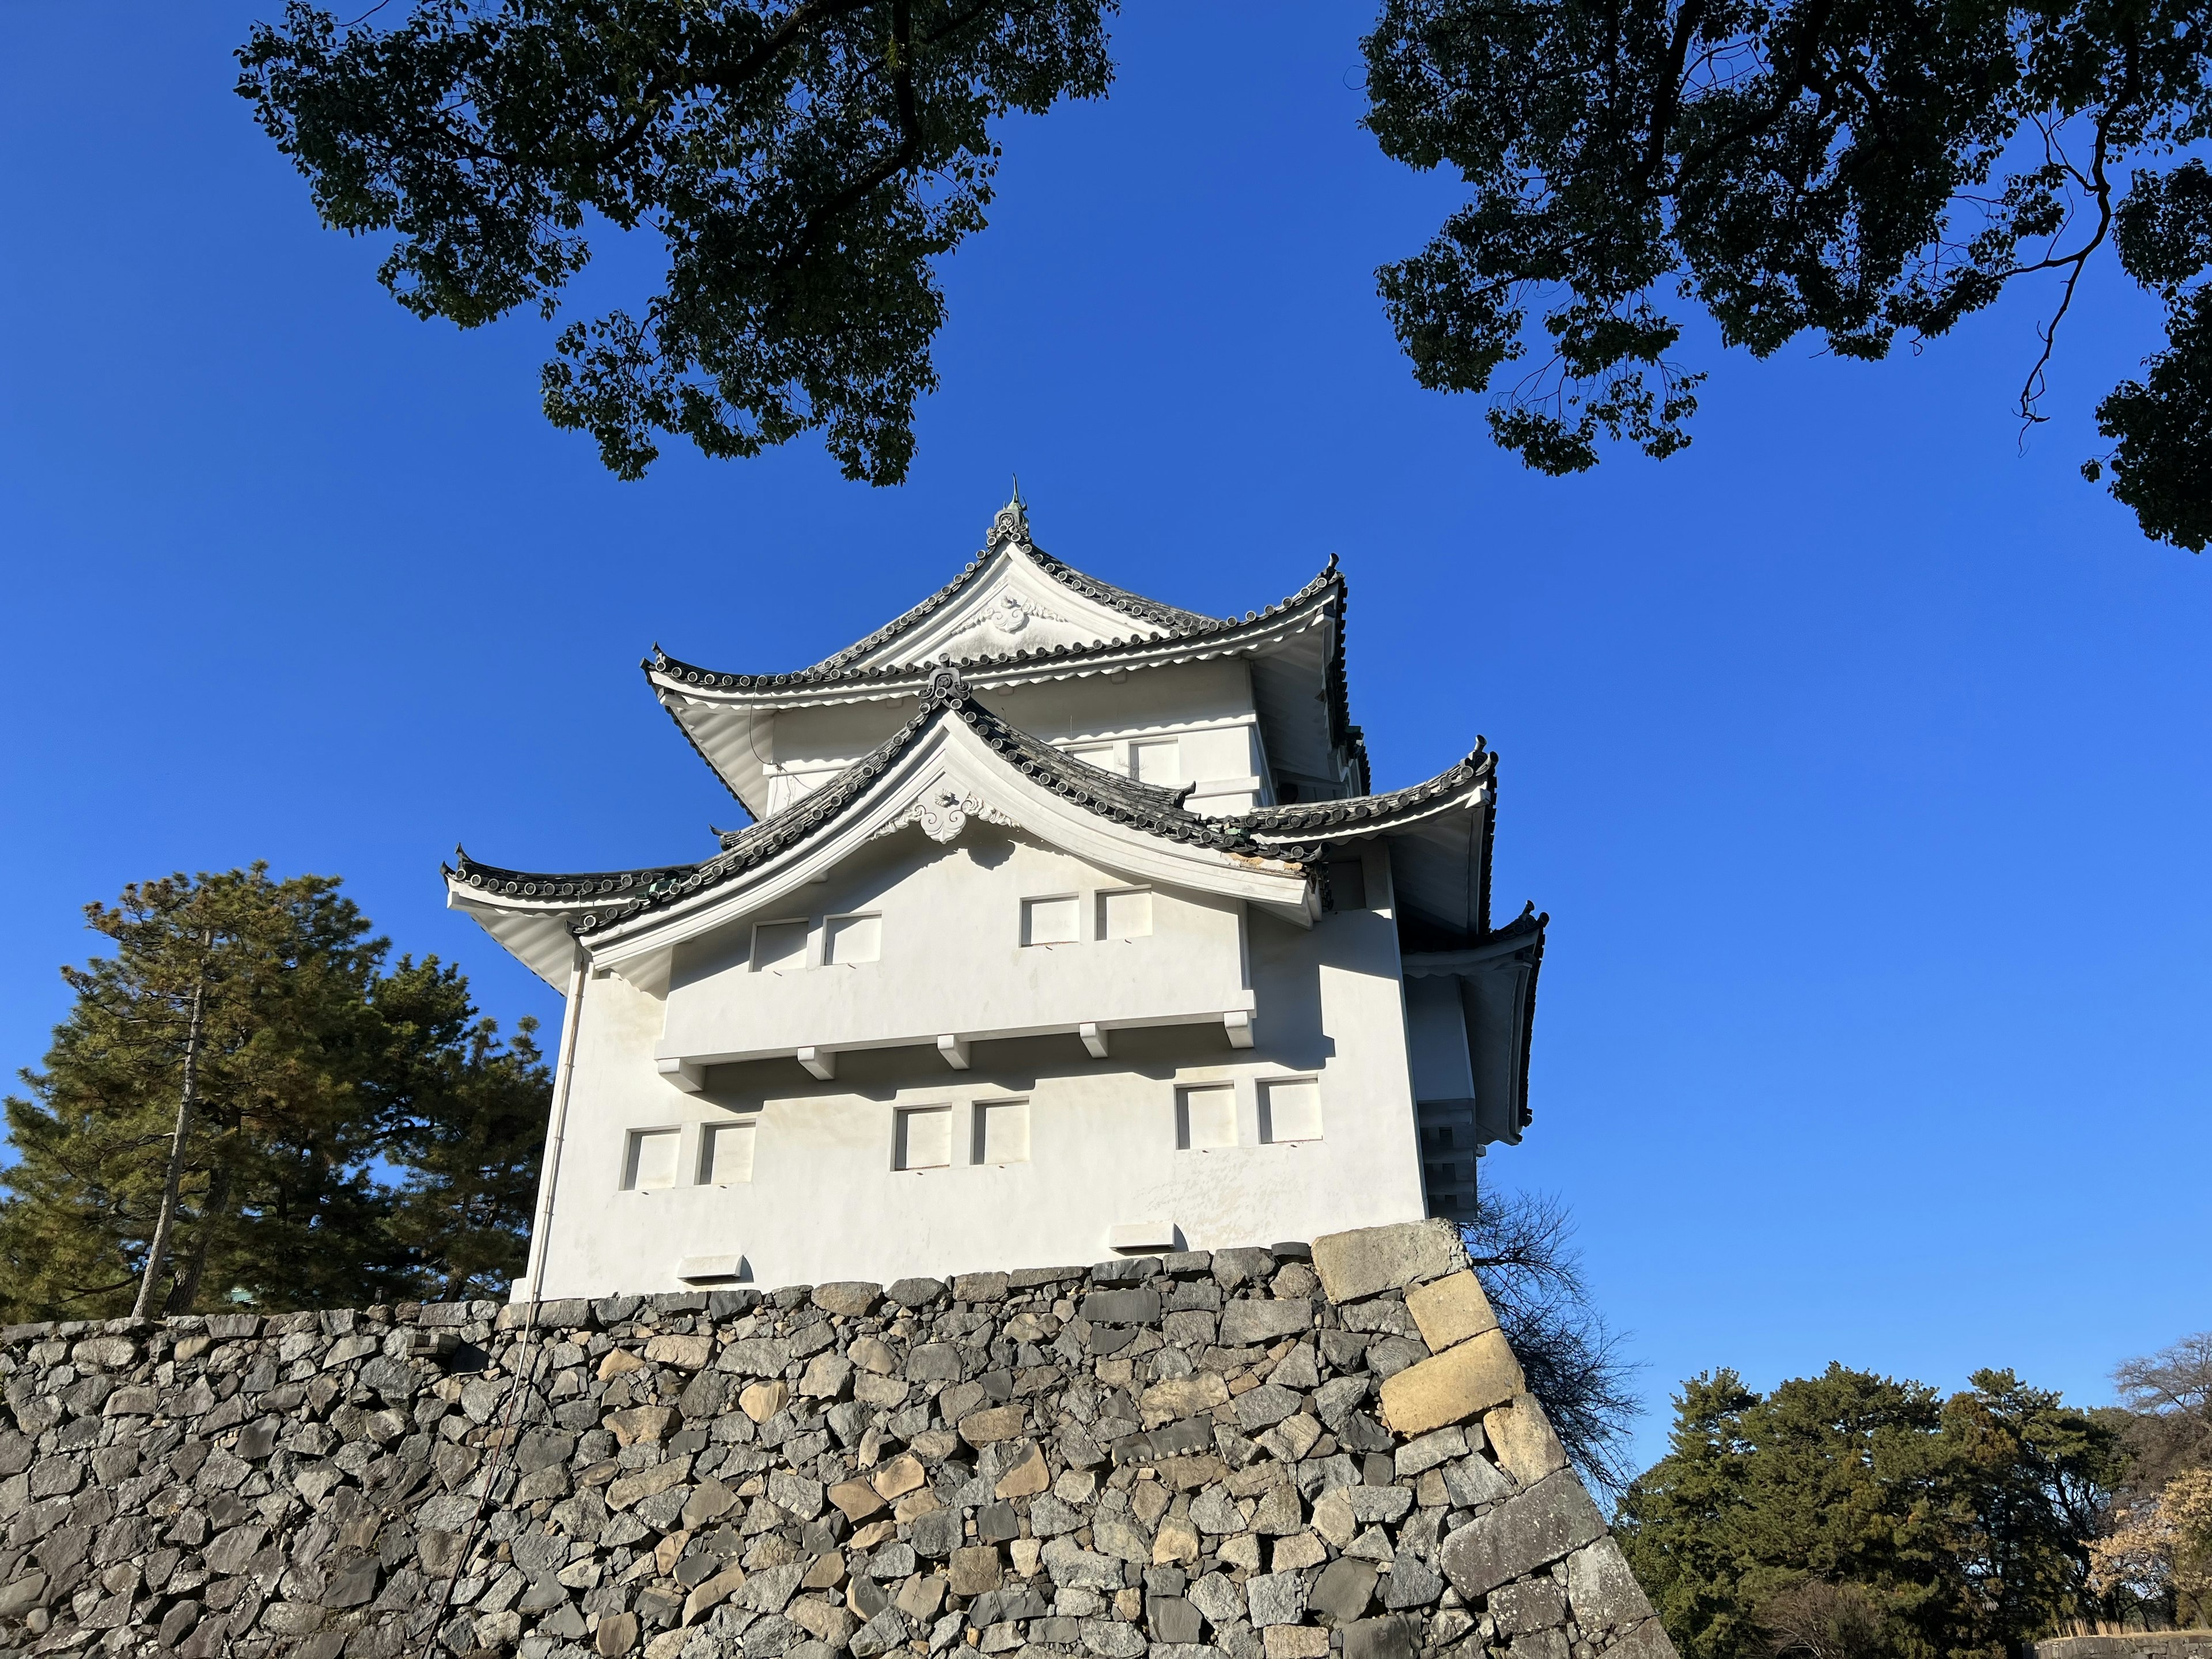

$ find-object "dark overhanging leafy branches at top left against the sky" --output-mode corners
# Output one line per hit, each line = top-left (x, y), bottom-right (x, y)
(239, 0), (1113, 484)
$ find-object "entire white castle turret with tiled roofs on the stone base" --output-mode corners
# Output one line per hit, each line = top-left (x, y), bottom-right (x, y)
(445, 498), (1544, 1298)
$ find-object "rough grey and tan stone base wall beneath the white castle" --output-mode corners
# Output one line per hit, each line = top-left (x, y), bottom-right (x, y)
(0, 1224), (1672, 1659)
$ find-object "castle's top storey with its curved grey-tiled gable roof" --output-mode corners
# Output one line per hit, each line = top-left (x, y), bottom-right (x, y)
(643, 495), (1367, 819)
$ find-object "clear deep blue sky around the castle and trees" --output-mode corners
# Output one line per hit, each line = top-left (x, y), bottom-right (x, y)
(0, 2), (2212, 1453)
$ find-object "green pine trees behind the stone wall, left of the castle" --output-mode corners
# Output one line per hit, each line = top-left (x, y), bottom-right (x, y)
(0, 865), (548, 1319)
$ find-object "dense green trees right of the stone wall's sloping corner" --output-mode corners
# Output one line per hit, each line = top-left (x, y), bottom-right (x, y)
(1617, 1365), (2117, 1659)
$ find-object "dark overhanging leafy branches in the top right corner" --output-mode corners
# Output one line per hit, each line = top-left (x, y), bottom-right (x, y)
(1365, 0), (2212, 551)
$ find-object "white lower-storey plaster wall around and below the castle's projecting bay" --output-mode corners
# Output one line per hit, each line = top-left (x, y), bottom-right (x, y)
(540, 844), (1422, 1296)
